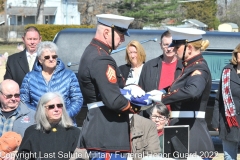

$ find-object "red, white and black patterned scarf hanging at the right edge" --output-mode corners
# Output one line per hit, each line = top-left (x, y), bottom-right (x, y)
(222, 68), (239, 127)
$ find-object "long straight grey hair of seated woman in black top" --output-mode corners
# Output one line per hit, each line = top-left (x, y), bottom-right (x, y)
(35, 92), (73, 131)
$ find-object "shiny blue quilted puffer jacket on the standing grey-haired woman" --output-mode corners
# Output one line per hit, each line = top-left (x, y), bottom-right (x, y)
(20, 58), (83, 122)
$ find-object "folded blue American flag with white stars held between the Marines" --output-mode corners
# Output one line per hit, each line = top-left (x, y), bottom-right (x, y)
(120, 89), (152, 106)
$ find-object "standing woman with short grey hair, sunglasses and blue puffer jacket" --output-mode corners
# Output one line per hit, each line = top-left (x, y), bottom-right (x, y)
(20, 41), (83, 125)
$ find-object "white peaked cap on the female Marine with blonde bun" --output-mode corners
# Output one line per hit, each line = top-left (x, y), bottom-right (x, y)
(168, 27), (206, 47)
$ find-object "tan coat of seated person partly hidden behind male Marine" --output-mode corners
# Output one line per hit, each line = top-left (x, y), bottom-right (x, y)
(131, 114), (160, 160)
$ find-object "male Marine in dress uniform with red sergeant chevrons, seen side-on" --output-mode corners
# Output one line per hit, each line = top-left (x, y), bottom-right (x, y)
(78, 14), (145, 159)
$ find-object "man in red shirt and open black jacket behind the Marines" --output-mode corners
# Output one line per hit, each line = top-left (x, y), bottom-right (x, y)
(138, 31), (183, 118)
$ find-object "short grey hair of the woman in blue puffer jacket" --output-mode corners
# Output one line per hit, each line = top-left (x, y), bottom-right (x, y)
(37, 41), (58, 57)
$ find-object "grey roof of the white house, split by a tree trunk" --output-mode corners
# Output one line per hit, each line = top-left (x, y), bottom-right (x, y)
(7, 7), (57, 16)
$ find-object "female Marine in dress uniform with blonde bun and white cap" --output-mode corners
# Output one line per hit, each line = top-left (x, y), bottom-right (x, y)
(149, 27), (215, 159)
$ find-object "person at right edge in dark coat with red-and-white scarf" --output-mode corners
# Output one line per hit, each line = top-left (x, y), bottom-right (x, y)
(212, 44), (240, 160)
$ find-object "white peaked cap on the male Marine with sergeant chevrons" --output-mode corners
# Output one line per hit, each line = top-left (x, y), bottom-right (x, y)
(96, 14), (134, 35)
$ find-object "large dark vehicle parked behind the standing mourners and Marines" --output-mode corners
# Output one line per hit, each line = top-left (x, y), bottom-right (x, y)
(53, 28), (240, 134)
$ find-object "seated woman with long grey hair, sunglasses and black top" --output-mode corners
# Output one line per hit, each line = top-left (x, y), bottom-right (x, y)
(16, 92), (80, 160)
